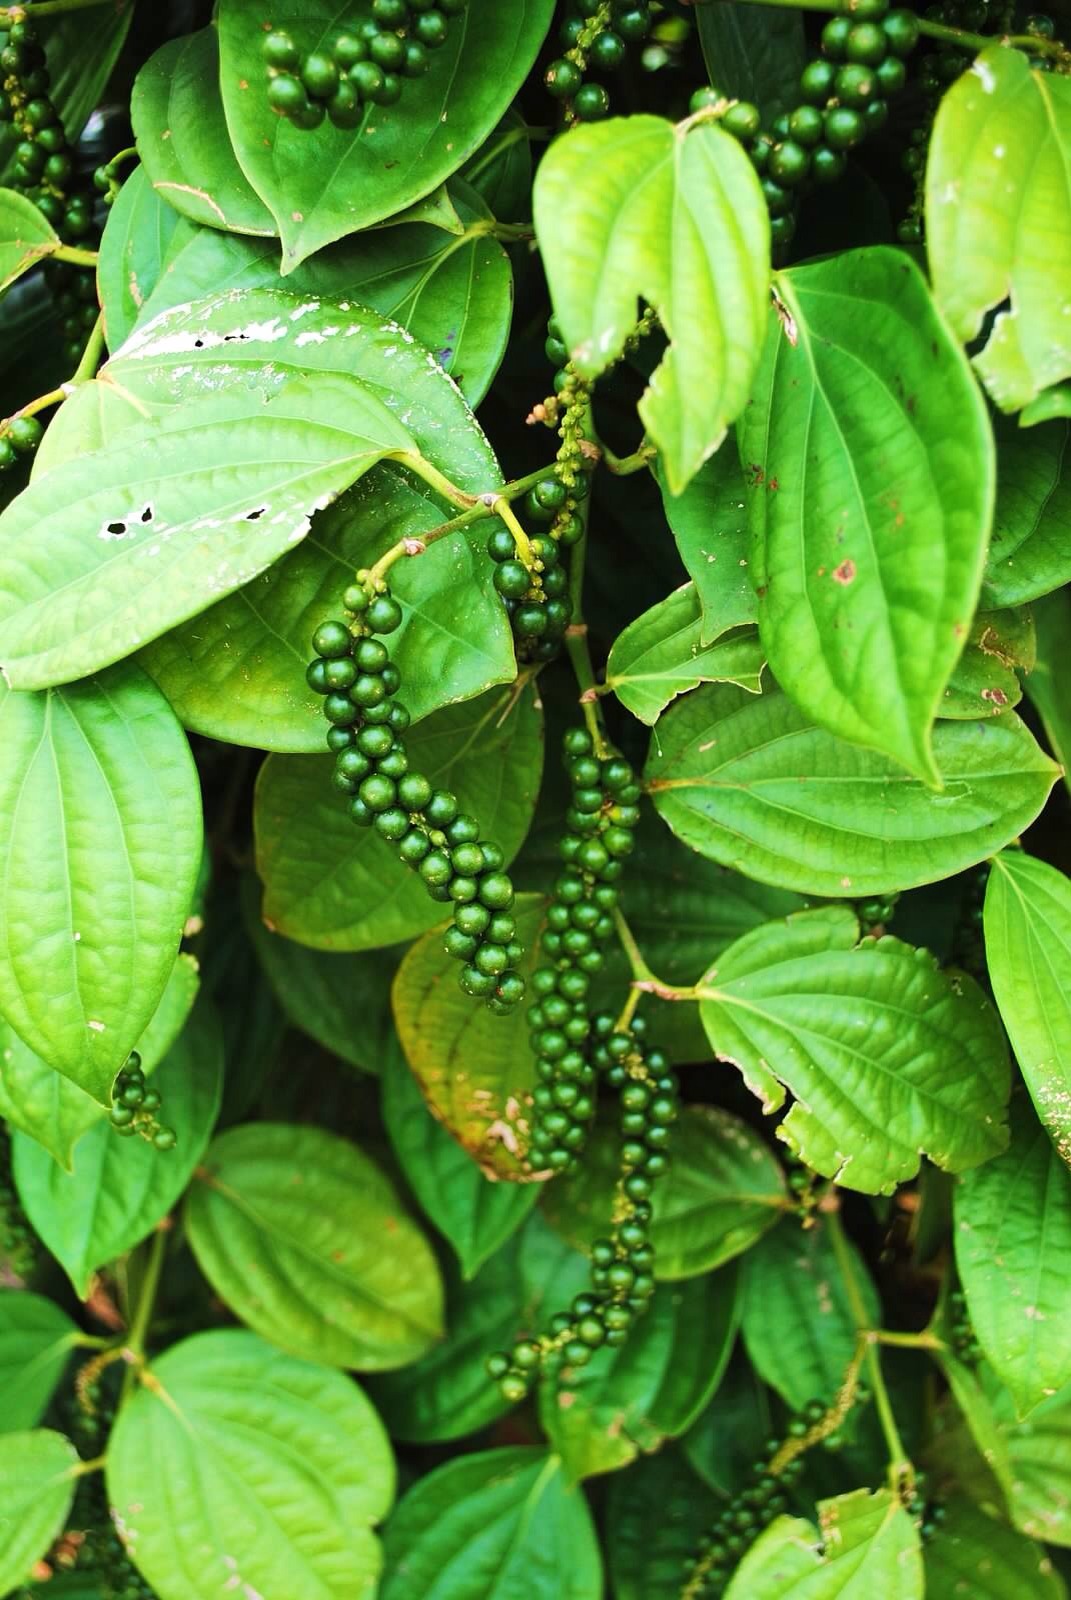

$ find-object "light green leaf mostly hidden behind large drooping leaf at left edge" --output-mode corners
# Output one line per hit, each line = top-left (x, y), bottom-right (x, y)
(0, 955), (199, 1171)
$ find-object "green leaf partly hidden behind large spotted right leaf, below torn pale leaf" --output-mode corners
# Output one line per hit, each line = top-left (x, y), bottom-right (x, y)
(656, 442), (759, 645)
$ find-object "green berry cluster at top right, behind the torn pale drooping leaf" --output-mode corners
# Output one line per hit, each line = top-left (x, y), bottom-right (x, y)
(692, 0), (919, 245)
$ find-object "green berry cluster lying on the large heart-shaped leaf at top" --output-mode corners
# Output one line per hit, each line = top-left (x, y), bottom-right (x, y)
(261, 0), (467, 128)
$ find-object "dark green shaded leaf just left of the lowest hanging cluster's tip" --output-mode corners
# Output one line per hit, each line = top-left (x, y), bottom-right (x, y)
(368, 1228), (521, 1445)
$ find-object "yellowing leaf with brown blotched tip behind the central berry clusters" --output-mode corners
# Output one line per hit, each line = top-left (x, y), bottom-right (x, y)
(392, 896), (543, 1182)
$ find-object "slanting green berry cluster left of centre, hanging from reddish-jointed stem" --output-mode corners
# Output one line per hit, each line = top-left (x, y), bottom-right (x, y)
(307, 571), (525, 1013)
